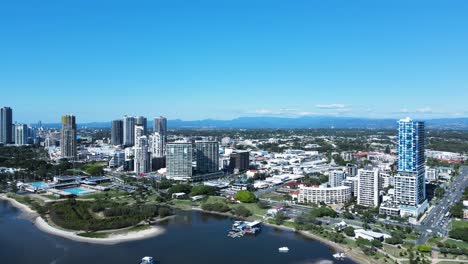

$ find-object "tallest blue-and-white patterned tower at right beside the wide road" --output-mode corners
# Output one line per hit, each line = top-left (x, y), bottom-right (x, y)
(394, 117), (426, 207)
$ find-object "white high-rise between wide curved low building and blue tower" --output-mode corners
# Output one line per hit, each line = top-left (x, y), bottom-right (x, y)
(357, 169), (379, 207)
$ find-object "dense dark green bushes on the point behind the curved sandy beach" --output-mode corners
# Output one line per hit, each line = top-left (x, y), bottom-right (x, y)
(49, 199), (169, 231)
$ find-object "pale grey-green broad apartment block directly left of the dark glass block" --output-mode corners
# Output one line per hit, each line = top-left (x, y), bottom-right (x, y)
(166, 142), (193, 180)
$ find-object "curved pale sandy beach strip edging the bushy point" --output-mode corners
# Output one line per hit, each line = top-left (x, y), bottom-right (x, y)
(0, 194), (166, 245)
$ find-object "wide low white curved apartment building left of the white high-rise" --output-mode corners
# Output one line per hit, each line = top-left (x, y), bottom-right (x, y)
(298, 186), (351, 204)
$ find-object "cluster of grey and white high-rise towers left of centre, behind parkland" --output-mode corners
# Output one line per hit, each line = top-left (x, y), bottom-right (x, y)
(111, 116), (219, 180)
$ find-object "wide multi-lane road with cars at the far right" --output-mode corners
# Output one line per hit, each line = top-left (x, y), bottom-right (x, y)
(416, 166), (468, 244)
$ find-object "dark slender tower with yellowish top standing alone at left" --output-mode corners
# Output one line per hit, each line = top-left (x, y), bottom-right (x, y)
(60, 115), (76, 159)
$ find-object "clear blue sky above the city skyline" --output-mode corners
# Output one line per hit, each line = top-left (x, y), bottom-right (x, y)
(0, 0), (468, 122)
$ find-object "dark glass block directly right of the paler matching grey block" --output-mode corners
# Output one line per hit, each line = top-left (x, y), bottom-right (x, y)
(195, 141), (219, 173)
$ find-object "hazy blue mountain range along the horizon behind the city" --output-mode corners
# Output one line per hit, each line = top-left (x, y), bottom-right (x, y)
(39, 116), (468, 130)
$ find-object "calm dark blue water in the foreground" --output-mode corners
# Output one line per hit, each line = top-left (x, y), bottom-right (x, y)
(0, 201), (353, 264)
